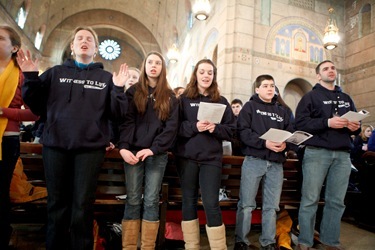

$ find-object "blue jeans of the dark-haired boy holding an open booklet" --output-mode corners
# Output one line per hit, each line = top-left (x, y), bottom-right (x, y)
(235, 156), (283, 246)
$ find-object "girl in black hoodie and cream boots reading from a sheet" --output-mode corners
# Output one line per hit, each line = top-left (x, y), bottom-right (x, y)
(174, 59), (235, 249)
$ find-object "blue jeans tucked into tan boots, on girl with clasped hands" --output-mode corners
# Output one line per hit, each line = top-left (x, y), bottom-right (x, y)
(123, 153), (168, 221)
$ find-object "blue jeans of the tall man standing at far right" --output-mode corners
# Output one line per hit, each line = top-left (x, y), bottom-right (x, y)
(298, 146), (351, 246)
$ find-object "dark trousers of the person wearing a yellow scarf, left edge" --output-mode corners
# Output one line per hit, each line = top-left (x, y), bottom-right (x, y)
(0, 136), (20, 249)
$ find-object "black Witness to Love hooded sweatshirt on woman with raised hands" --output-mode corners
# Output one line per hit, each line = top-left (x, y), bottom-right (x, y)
(22, 60), (127, 150)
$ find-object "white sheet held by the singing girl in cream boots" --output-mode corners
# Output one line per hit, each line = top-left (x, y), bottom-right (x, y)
(197, 102), (226, 124)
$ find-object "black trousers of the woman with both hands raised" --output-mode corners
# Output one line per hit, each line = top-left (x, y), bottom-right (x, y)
(43, 147), (105, 250)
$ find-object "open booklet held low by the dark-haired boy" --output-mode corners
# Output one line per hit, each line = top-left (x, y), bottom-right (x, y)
(259, 128), (312, 145)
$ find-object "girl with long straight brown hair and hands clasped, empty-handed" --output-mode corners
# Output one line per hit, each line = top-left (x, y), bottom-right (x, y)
(119, 51), (178, 249)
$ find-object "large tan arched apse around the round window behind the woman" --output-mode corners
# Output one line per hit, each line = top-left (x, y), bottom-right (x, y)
(41, 9), (160, 71)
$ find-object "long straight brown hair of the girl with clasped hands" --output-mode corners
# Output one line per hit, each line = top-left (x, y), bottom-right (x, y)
(134, 51), (173, 121)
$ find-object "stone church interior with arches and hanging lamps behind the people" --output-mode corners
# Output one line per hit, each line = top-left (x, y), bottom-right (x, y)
(0, 0), (375, 249)
